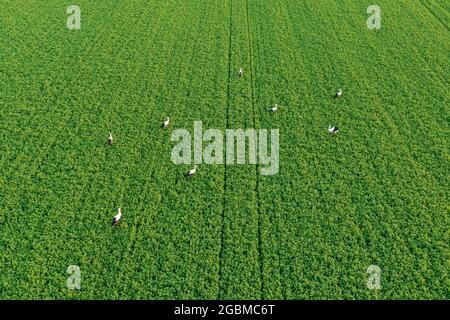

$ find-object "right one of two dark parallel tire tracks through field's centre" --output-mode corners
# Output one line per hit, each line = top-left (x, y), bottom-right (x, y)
(245, 0), (264, 299)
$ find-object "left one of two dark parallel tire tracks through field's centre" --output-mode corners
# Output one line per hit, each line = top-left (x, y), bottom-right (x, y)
(217, 0), (233, 299)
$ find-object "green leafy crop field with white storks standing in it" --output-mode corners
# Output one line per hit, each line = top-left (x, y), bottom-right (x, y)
(0, 0), (450, 300)
